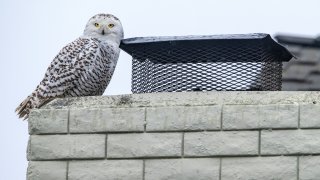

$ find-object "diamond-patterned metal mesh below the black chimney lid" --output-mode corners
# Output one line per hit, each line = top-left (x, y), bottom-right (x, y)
(132, 59), (282, 93)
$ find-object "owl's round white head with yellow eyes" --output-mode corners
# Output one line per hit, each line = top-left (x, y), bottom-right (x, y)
(84, 14), (123, 44)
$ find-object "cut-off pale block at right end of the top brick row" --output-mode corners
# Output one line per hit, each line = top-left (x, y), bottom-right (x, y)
(300, 104), (320, 128)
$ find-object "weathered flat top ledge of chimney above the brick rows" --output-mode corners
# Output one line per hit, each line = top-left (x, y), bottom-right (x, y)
(42, 91), (320, 109)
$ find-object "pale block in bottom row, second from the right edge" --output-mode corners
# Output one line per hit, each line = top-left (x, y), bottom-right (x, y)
(221, 157), (297, 180)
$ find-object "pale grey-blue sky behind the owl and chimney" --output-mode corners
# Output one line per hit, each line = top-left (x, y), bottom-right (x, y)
(0, 0), (320, 180)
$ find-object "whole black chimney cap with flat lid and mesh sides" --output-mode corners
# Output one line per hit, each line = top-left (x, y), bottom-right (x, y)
(120, 34), (292, 93)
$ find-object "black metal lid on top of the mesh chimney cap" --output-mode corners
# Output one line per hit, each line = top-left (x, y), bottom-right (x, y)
(120, 33), (293, 62)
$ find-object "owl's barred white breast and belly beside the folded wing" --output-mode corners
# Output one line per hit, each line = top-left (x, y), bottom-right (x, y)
(65, 40), (120, 97)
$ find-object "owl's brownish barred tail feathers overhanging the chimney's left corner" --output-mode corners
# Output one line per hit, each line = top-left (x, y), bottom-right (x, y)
(15, 93), (52, 120)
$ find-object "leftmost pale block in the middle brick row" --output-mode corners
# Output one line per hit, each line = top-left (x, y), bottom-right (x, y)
(29, 134), (106, 160)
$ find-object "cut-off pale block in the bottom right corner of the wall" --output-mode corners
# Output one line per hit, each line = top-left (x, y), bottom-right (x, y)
(299, 156), (320, 180)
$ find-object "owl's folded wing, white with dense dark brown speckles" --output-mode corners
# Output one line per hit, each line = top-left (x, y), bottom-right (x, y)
(36, 38), (100, 98)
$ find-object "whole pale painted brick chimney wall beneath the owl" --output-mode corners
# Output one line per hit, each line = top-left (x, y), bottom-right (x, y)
(27, 92), (320, 180)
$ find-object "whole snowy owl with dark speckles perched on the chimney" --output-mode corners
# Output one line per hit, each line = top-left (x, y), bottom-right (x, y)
(16, 14), (123, 119)
